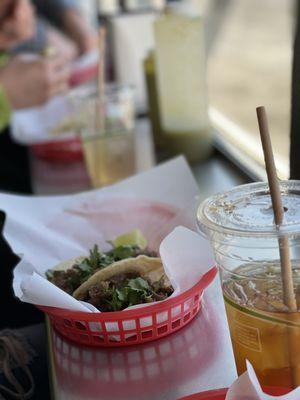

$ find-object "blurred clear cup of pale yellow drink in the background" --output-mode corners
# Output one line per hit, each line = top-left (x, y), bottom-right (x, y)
(72, 85), (136, 187)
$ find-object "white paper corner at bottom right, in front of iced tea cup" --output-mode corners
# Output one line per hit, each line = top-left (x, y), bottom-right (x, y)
(225, 361), (300, 400)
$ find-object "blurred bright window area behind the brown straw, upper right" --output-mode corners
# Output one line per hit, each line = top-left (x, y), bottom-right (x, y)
(206, 0), (294, 178)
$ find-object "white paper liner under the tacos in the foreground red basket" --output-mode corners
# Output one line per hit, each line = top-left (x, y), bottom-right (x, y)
(0, 158), (213, 311)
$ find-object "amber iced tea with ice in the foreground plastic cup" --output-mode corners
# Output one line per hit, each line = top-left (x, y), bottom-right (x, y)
(223, 263), (300, 387)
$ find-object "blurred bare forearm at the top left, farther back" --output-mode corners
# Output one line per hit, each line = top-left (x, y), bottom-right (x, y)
(63, 9), (98, 54)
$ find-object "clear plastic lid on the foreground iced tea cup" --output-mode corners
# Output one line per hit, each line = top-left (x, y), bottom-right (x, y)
(197, 181), (300, 236)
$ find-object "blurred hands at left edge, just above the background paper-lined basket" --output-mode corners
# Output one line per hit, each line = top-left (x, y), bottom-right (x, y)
(0, 56), (70, 109)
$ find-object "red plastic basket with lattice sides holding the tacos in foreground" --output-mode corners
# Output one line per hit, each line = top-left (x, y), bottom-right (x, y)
(39, 267), (217, 347)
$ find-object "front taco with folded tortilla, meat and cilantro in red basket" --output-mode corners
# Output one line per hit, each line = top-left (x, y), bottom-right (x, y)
(73, 255), (174, 312)
